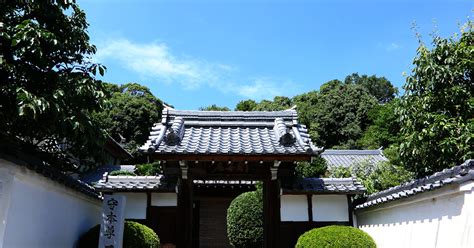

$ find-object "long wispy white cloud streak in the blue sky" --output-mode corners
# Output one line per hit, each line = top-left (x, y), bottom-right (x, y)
(94, 39), (293, 100)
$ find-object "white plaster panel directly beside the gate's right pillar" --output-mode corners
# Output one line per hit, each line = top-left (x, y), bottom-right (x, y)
(280, 195), (309, 221)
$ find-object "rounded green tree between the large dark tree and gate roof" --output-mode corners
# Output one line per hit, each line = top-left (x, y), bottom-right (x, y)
(94, 83), (163, 155)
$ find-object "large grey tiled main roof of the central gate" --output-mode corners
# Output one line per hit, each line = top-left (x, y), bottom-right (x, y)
(141, 109), (321, 155)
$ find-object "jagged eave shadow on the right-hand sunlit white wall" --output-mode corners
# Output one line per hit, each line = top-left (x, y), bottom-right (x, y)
(357, 188), (465, 226)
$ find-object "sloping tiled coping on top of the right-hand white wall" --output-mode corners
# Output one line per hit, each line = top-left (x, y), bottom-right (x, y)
(356, 159), (474, 209)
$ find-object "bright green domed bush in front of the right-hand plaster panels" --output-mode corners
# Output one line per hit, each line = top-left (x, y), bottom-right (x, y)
(296, 226), (377, 248)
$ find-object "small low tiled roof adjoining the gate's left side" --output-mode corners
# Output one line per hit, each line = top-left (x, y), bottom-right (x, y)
(94, 175), (176, 192)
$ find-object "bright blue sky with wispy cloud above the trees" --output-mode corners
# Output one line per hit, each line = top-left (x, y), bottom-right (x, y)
(78, 0), (474, 109)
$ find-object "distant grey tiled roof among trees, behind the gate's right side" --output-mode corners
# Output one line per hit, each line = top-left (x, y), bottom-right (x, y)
(321, 150), (388, 167)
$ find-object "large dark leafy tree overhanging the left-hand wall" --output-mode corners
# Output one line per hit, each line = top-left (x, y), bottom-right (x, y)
(0, 1), (105, 170)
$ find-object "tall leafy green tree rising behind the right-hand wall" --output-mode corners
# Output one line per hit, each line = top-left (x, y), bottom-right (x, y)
(398, 21), (474, 177)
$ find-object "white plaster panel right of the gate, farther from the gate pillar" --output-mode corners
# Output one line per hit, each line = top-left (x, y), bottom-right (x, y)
(312, 195), (349, 221)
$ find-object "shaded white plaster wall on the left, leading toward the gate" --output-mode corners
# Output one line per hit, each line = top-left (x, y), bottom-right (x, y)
(0, 159), (102, 248)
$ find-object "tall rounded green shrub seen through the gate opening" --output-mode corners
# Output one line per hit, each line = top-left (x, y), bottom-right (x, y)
(227, 190), (263, 248)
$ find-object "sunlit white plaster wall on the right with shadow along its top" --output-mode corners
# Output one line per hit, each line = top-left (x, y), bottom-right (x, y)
(357, 182), (474, 248)
